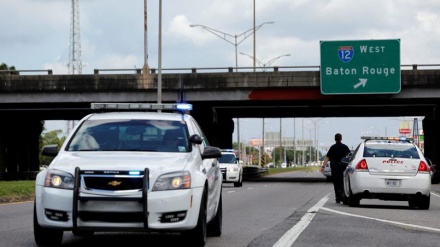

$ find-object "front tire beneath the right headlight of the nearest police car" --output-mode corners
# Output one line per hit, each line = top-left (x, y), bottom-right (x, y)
(183, 189), (207, 246)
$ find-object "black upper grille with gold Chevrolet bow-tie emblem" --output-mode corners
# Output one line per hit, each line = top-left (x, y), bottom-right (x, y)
(84, 176), (143, 191)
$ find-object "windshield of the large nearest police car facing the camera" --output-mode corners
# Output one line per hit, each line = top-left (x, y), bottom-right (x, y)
(67, 119), (189, 152)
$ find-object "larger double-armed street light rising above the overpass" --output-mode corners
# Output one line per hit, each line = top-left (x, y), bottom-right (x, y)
(189, 21), (275, 72)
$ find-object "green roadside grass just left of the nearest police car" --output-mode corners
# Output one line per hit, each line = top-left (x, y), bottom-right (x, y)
(0, 180), (35, 203)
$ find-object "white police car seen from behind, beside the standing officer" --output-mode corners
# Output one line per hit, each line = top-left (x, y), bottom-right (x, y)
(342, 137), (431, 209)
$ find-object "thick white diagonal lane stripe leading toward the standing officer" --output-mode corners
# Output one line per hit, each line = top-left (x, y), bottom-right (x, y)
(273, 194), (330, 247)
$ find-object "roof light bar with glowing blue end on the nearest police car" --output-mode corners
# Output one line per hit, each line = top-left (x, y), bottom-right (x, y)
(91, 103), (192, 111)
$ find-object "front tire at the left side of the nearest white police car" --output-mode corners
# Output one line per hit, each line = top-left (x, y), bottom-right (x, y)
(34, 202), (64, 246)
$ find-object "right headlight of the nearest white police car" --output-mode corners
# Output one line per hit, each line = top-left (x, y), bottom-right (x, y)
(152, 171), (191, 191)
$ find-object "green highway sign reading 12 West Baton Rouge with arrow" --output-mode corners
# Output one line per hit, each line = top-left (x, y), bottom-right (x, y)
(320, 39), (401, 94)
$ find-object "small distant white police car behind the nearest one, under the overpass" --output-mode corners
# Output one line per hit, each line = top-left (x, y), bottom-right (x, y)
(219, 149), (243, 187)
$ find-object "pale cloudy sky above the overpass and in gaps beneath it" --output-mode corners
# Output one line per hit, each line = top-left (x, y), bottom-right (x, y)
(0, 0), (440, 149)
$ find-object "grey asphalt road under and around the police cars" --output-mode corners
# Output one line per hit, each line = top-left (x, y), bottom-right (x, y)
(0, 172), (440, 247)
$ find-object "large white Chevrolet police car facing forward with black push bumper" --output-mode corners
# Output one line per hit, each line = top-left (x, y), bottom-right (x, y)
(34, 103), (222, 246)
